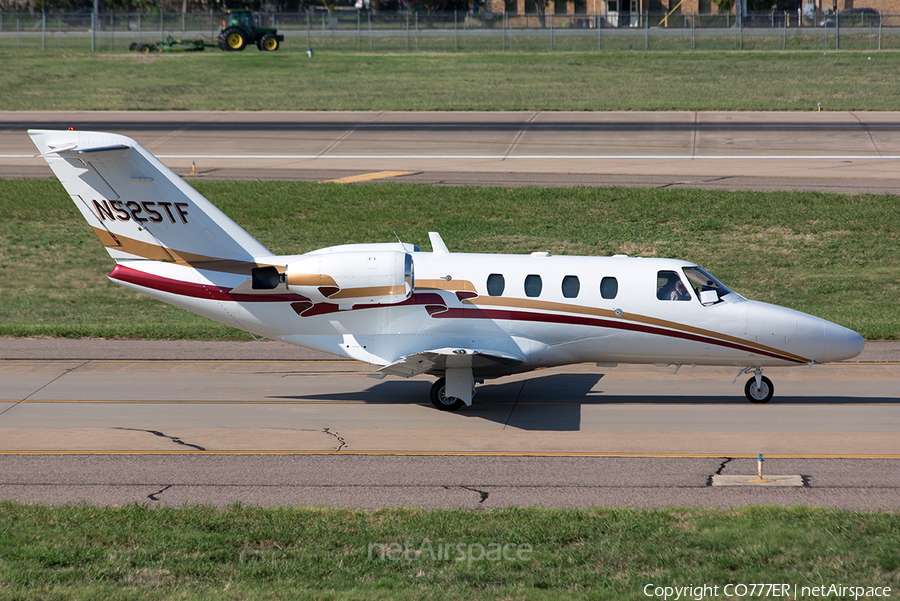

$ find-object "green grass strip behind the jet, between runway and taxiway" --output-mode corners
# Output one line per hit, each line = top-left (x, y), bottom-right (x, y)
(0, 180), (900, 340)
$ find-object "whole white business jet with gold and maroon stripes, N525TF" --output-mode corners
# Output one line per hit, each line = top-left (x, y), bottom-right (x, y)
(29, 130), (864, 411)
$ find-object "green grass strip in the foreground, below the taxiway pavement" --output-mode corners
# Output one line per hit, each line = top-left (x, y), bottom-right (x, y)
(0, 502), (900, 601)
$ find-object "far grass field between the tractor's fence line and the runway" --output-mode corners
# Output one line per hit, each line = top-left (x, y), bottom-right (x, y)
(0, 49), (900, 111)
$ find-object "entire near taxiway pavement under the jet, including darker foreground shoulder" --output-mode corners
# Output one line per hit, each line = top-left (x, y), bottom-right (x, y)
(0, 339), (900, 510)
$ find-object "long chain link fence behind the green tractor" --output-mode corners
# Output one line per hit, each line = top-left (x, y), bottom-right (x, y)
(0, 9), (900, 53)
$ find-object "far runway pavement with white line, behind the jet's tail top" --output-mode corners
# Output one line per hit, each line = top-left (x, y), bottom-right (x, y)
(0, 111), (900, 193)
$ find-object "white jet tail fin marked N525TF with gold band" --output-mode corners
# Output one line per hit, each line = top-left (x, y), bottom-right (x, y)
(28, 130), (272, 264)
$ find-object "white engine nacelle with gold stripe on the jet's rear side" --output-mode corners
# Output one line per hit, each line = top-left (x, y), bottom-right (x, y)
(285, 250), (415, 305)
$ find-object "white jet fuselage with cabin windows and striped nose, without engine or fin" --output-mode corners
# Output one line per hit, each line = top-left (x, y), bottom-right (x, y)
(112, 251), (863, 378)
